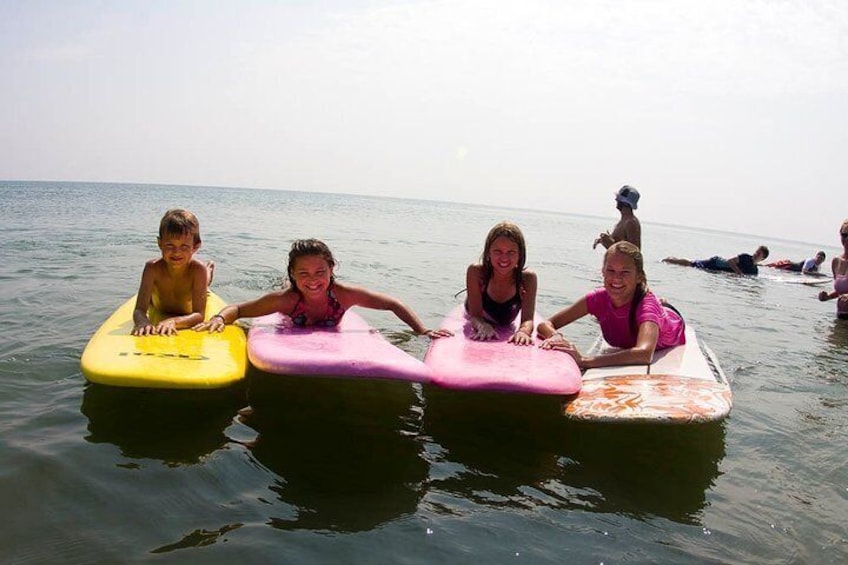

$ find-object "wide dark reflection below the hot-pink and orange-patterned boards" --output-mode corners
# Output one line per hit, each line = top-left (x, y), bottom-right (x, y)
(424, 388), (724, 524)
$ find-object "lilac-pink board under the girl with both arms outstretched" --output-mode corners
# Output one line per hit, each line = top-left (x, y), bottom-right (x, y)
(247, 310), (430, 383)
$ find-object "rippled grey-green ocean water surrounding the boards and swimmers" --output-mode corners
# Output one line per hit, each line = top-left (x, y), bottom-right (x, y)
(0, 182), (848, 564)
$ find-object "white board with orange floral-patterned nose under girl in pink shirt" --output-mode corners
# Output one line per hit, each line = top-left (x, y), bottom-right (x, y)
(564, 326), (733, 424)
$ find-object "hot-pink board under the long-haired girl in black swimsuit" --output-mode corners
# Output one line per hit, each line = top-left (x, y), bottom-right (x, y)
(424, 305), (580, 395)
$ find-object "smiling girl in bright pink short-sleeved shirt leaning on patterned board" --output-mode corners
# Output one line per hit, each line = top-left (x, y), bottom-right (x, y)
(537, 241), (686, 369)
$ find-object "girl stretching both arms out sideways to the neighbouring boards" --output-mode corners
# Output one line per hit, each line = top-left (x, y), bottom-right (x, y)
(194, 239), (452, 338)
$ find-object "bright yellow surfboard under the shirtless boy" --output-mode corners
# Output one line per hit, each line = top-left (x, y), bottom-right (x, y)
(80, 292), (247, 389)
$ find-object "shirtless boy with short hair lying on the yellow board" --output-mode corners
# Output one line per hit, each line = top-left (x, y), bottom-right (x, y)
(131, 209), (215, 335)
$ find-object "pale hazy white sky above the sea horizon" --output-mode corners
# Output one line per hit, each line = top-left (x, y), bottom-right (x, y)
(0, 0), (848, 246)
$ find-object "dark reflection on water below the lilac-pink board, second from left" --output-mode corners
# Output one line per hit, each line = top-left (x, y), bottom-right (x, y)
(242, 371), (427, 532)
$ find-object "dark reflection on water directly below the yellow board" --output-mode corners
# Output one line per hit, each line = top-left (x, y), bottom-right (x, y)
(80, 384), (245, 466)
